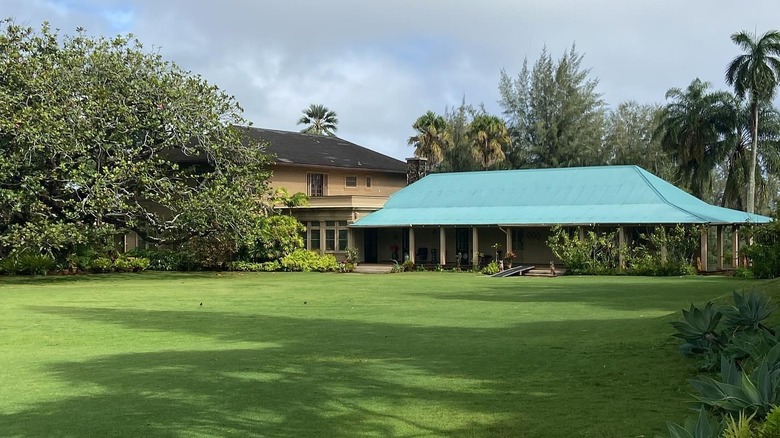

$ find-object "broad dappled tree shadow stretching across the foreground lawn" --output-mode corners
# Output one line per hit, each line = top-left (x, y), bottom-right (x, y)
(6, 307), (683, 437)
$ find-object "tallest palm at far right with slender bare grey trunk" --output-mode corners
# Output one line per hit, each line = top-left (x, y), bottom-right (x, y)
(726, 30), (780, 213)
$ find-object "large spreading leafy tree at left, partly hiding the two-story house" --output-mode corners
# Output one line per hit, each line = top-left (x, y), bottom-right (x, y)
(0, 19), (268, 255)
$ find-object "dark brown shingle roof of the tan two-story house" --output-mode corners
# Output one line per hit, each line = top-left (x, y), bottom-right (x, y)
(240, 127), (406, 173)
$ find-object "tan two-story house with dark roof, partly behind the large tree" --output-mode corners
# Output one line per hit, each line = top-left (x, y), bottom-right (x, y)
(239, 128), (407, 263)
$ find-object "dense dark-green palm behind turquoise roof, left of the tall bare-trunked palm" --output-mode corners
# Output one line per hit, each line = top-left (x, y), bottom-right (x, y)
(653, 79), (733, 198)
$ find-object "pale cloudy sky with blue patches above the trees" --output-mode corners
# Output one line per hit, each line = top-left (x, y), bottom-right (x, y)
(6, 0), (780, 159)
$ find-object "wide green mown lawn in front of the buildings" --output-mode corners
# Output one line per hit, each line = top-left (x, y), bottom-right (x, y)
(0, 273), (780, 437)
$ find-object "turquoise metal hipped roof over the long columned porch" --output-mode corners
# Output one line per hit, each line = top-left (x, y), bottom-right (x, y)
(352, 166), (771, 227)
